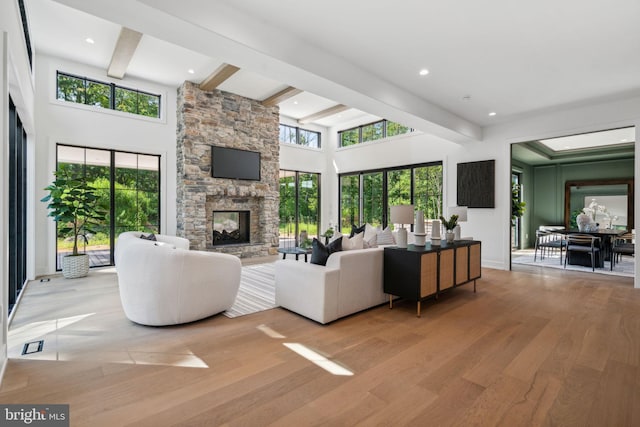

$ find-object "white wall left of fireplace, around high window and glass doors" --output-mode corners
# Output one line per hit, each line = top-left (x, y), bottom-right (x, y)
(34, 55), (176, 275)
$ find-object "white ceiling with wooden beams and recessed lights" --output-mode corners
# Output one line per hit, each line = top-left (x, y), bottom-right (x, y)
(25, 0), (640, 150)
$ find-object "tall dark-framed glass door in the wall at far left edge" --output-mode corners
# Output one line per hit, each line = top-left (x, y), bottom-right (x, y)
(8, 98), (28, 312)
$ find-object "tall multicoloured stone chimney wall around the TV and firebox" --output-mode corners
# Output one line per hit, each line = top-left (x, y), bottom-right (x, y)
(176, 82), (280, 257)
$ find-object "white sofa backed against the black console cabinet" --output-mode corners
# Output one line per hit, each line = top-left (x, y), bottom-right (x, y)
(276, 247), (387, 323)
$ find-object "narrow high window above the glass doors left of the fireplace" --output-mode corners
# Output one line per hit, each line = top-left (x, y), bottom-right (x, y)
(57, 71), (160, 117)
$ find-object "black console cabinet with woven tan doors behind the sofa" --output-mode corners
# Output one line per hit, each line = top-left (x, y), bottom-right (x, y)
(384, 240), (482, 317)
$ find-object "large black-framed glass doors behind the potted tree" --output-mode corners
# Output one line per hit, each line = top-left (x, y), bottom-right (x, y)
(56, 145), (160, 269)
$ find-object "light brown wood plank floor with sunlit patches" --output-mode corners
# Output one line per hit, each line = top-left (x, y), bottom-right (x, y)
(0, 267), (640, 427)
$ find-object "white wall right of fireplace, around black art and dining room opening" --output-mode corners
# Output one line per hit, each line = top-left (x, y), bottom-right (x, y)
(310, 97), (640, 276)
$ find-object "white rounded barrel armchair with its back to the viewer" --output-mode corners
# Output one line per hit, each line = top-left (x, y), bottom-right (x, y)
(115, 231), (241, 326)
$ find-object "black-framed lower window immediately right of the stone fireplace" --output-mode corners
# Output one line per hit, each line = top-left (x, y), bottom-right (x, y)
(280, 170), (320, 247)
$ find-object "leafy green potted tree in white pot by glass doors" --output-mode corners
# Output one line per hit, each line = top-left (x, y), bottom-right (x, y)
(41, 164), (107, 279)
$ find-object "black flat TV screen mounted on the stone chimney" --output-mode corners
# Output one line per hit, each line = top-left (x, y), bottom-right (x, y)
(211, 146), (260, 181)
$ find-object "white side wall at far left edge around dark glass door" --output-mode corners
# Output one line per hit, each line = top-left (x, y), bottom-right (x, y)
(0, 1), (35, 382)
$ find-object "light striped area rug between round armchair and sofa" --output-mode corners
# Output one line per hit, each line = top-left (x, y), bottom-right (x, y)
(223, 263), (276, 317)
